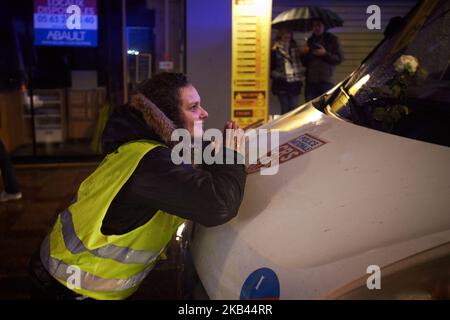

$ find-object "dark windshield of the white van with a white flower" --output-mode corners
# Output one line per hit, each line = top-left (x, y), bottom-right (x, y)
(324, 0), (450, 146)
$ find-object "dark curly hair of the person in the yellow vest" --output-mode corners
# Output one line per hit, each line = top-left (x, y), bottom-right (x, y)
(135, 72), (191, 128)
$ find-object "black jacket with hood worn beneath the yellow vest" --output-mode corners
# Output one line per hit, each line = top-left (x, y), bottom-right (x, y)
(101, 99), (246, 235)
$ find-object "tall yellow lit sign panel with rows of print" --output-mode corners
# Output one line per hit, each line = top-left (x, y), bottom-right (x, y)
(231, 0), (272, 128)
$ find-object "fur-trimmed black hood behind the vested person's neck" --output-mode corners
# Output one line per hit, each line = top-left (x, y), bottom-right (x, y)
(102, 94), (175, 154)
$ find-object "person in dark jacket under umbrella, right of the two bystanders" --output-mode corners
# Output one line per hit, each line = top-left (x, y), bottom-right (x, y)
(301, 19), (343, 101)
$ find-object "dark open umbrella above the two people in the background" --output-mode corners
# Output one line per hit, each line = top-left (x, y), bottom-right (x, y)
(272, 7), (344, 32)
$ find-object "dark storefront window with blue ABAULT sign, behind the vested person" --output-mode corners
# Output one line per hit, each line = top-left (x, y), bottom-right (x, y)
(0, 0), (184, 163)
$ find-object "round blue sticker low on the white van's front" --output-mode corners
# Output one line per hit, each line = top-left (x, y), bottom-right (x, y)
(240, 268), (280, 300)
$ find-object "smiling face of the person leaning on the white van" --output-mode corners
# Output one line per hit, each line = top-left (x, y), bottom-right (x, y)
(180, 85), (208, 137)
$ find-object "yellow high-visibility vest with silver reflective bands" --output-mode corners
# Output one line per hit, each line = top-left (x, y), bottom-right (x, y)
(41, 140), (184, 299)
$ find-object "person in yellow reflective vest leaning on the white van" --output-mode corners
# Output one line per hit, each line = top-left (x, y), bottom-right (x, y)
(30, 73), (246, 299)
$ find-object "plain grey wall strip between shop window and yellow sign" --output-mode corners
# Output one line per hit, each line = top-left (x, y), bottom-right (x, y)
(186, 0), (231, 128)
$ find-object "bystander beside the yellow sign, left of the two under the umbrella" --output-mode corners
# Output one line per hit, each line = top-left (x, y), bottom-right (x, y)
(270, 29), (303, 114)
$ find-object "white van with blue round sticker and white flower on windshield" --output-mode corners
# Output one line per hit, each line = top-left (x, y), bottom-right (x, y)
(191, 1), (450, 299)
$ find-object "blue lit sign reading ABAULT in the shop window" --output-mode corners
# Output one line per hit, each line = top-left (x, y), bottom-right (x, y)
(34, 0), (98, 47)
